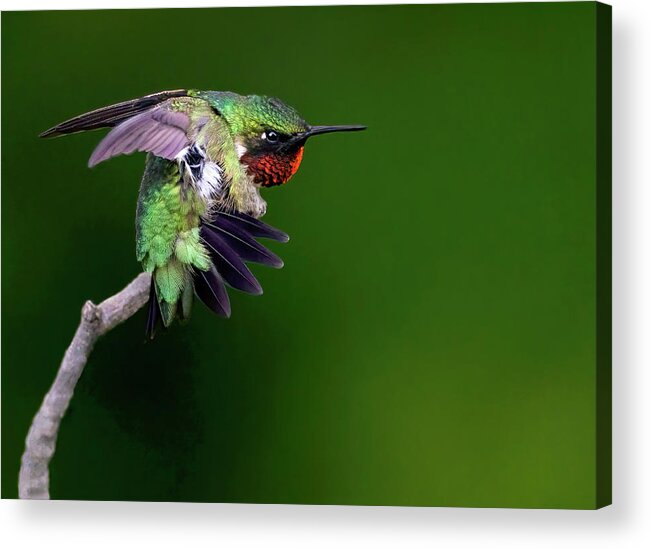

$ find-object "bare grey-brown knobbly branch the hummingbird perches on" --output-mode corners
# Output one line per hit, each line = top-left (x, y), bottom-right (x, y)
(18, 273), (151, 499)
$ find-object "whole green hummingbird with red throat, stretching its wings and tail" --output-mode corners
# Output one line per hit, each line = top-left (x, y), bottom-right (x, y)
(41, 89), (365, 338)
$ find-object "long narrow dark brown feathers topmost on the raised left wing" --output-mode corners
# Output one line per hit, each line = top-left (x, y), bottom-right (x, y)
(40, 90), (188, 137)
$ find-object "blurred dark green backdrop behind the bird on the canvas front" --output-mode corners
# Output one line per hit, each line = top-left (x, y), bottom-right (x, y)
(2, 3), (598, 508)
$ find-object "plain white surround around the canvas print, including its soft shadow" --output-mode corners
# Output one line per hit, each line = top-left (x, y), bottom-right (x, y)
(0, 0), (651, 549)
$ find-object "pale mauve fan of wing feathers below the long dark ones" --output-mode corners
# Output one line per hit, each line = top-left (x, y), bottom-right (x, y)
(88, 105), (190, 168)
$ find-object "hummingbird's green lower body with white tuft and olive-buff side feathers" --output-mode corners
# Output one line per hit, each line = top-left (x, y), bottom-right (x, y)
(136, 97), (261, 326)
